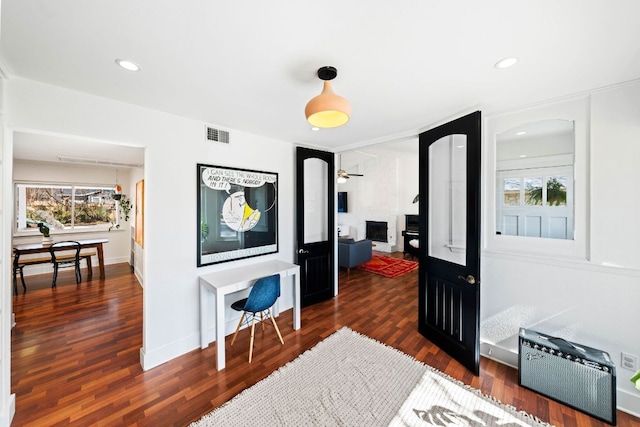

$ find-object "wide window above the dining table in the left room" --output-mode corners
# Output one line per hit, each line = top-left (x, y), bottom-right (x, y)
(15, 183), (119, 231)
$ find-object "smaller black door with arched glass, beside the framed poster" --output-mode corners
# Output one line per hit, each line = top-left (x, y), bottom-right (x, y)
(296, 147), (336, 307)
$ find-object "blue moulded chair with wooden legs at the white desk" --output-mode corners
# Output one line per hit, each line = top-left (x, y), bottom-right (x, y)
(231, 274), (284, 363)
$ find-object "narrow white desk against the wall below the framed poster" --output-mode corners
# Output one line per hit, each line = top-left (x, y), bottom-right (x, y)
(200, 260), (300, 370)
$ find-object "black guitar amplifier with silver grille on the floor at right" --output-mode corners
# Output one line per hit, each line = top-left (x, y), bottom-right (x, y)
(518, 328), (616, 425)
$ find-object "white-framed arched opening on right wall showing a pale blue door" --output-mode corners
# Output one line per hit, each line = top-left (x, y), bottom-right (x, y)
(483, 102), (592, 262)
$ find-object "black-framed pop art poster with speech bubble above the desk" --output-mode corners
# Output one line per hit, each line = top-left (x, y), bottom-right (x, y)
(197, 164), (278, 267)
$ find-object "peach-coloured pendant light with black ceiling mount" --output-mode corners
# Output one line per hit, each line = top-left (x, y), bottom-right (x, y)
(304, 66), (351, 128)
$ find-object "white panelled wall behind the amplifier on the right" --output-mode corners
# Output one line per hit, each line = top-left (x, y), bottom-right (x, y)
(481, 83), (640, 415)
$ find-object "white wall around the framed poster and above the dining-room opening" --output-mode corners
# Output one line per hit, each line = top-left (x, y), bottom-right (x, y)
(3, 78), (295, 369)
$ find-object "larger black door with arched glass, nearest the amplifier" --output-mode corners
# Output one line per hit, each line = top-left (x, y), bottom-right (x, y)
(418, 111), (480, 375)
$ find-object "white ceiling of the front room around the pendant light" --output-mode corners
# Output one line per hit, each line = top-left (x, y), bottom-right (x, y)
(0, 0), (640, 164)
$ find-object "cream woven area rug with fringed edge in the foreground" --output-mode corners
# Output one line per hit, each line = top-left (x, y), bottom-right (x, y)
(191, 328), (547, 427)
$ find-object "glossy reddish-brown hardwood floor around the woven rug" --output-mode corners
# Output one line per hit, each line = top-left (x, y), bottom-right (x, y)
(11, 254), (640, 427)
